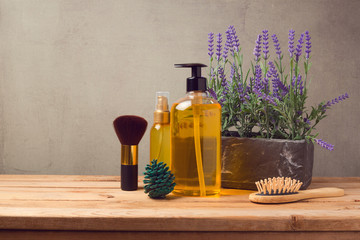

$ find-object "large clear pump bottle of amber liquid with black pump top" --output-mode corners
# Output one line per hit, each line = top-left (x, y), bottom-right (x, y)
(170, 63), (221, 197)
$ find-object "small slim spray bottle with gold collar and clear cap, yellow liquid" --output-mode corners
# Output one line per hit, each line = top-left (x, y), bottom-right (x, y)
(150, 92), (170, 166)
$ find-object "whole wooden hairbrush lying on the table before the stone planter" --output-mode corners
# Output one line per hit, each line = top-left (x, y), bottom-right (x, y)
(249, 177), (344, 203)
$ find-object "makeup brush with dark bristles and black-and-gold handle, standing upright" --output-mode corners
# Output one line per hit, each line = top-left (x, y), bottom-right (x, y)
(114, 115), (147, 191)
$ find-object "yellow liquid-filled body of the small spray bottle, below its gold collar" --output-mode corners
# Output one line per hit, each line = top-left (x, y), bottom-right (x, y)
(150, 123), (170, 167)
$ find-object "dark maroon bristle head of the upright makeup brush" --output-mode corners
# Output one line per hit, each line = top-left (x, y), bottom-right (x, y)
(114, 115), (147, 145)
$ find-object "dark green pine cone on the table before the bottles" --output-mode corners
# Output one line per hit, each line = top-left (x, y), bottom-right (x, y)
(144, 159), (175, 198)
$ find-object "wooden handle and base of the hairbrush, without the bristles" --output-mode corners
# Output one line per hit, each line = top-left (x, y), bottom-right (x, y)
(249, 188), (344, 203)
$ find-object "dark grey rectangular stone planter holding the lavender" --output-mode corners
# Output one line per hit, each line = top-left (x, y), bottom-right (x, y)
(221, 137), (314, 190)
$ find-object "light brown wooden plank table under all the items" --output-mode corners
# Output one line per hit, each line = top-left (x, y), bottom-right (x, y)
(0, 175), (360, 240)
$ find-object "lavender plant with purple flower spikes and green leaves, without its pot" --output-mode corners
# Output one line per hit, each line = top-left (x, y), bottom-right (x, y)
(208, 26), (349, 151)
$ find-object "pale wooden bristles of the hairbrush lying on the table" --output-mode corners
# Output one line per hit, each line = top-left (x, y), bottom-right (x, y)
(255, 177), (302, 195)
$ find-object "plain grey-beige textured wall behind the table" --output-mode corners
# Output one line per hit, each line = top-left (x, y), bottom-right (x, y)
(0, 0), (360, 176)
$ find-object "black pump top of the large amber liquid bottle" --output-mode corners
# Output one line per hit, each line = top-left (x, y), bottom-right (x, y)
(174, 63), (207, 92)
